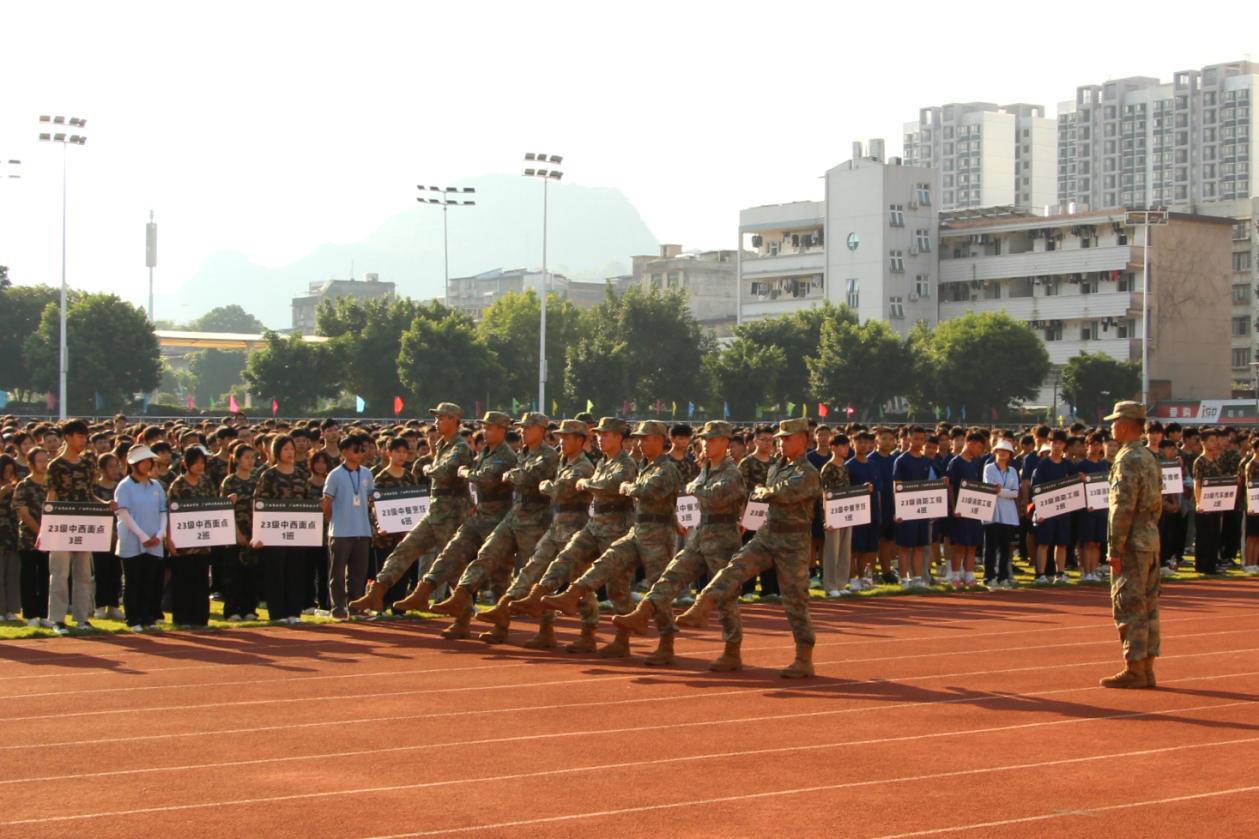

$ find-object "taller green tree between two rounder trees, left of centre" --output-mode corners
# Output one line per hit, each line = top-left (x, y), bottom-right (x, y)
(315, 297), (440, 416)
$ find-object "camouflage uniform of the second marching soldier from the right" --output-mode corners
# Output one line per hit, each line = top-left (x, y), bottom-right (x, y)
(647, 456), (745, 644)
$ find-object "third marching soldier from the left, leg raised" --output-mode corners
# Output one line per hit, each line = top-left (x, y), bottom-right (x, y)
(433, 413), (559, 644)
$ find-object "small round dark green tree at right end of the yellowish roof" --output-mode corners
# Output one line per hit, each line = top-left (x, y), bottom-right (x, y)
(244, 331), (341, 416)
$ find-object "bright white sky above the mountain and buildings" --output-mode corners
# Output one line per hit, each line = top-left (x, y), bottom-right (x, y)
(0, 0), (1259, 313)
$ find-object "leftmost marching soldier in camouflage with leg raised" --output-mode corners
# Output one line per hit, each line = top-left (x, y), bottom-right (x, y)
(349, 402), (472, 612)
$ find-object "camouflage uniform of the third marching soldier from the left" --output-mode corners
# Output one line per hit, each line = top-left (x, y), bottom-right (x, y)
(460, 414), (559, 592)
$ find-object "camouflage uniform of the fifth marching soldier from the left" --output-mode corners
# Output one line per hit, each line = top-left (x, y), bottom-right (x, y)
(539, 438), (639, 626)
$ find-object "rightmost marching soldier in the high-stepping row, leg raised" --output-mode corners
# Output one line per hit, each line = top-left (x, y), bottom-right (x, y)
(677, 418), (822, 679)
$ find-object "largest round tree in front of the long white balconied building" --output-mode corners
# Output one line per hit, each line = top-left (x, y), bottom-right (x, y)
(915, 312), (1050, 421)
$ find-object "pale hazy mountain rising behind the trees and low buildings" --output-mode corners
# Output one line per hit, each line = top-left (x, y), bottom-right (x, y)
(166, 175), (657, 329)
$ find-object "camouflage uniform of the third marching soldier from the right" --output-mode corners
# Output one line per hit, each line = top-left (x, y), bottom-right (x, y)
(577, 440), (682, 632)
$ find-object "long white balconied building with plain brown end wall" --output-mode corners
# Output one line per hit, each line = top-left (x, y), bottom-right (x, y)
(939, 209), (1234, 412)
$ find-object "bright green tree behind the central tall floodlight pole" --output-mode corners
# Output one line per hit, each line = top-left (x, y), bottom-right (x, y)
(477, 288), (588, 412)
